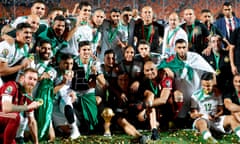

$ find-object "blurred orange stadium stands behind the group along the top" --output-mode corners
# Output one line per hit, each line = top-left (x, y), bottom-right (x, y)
(0, 0), (240, 23)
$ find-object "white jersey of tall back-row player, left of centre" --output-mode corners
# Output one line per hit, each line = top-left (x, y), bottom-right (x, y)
(60, 25), (93, 56)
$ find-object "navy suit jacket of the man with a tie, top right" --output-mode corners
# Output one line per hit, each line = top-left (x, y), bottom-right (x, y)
(214, 17), (240, 40)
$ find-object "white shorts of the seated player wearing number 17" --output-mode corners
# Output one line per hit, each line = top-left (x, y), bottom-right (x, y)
(193, 115), (231, 134)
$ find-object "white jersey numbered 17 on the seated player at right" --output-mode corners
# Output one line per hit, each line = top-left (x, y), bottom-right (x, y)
(191, 89), (223, 115)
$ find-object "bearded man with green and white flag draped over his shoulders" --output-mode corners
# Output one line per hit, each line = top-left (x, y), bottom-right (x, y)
(158, 39), (215, 126)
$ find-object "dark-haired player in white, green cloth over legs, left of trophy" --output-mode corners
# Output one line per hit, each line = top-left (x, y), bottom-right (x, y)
(71, 41), (105, 134)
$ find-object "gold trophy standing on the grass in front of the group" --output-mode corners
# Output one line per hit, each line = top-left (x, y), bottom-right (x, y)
(101, 108), (115, 137)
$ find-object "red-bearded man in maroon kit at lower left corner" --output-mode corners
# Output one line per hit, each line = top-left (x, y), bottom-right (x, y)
(0, 69), (41, 144)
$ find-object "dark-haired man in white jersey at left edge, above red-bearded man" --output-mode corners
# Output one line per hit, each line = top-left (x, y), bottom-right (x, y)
(0, 23), (32, 85)
